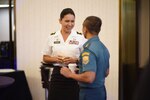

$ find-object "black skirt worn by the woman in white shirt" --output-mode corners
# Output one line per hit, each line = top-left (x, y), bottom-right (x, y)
(48, 67), (79, 100)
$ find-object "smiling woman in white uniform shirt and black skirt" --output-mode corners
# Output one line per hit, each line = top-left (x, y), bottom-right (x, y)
(43, 8), (86, 100)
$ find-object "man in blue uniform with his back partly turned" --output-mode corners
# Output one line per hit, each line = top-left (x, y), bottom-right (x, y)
(61, 16), (110, 100)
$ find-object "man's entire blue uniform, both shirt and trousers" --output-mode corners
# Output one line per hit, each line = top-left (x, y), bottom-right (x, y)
(79, 36), (110, 100)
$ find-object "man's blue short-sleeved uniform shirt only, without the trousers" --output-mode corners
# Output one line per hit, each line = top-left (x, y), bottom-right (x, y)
(79, 36), (110, 88)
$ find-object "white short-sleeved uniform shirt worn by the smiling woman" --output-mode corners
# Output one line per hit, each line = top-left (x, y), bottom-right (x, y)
(43, 31), (87, 65)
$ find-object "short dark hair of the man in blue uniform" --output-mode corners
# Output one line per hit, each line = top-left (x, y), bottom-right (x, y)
(83, 16), (102, 34)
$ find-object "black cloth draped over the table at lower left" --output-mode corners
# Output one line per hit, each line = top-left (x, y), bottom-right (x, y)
(0, 70), (31, 100)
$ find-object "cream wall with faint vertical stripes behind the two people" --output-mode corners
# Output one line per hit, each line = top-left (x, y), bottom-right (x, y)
(16, 0), (119, 100)
